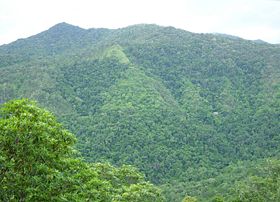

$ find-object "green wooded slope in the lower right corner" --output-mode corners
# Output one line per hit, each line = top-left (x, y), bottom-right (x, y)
(162, 159), (280, 202)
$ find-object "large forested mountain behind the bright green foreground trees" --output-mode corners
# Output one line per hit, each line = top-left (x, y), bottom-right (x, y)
(0, 23), (280, 201)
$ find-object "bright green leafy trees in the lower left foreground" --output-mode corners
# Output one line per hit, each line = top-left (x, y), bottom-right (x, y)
(0, 99), (164, 201)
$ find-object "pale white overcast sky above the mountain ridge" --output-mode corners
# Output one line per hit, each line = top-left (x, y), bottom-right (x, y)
(0, 0), (280, 45)
